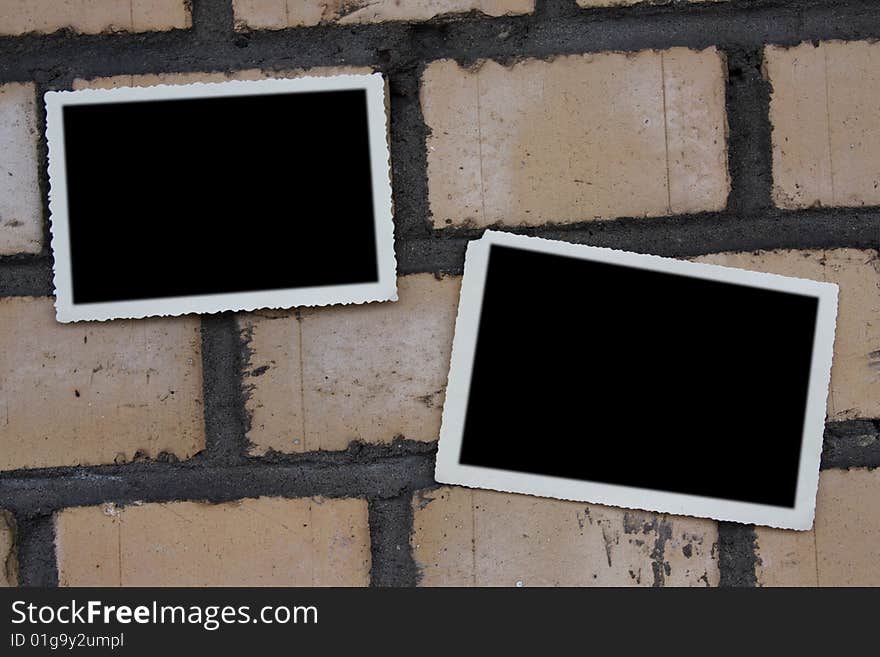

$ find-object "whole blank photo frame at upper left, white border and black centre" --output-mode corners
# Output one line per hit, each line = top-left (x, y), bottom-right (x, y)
(45, 74), (397, 322)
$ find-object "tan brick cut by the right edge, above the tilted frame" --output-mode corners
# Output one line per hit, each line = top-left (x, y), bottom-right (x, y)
(764, 41), (880, 209)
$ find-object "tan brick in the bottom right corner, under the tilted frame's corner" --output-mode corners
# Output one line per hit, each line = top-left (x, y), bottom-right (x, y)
(757, 468), (880, 586)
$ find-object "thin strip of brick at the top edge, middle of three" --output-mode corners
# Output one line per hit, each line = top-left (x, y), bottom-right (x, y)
(232, 0), (535, 30)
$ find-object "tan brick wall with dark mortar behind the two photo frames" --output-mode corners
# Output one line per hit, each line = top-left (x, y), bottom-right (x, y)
(0, 0), (880, 586)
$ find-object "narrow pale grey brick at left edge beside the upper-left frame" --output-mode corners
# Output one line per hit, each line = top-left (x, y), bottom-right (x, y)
(0, 82), (43, 255)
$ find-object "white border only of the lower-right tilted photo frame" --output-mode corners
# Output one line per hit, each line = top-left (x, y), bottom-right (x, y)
(434, 231), (837, 530)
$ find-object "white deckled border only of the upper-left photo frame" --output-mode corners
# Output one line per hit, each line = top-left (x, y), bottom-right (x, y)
(44, 73), (397, 322)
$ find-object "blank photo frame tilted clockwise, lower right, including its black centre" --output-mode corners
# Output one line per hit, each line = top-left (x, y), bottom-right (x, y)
(435, 231), (837, 529)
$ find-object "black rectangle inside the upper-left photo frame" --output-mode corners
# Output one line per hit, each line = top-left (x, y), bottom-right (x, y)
(63, 90), (378, 303)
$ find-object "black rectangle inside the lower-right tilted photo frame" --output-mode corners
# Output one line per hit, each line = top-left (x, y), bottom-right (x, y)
(460, 245), (818, 507)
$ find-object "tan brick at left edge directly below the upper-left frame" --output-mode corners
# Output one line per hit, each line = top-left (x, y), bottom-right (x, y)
(0, 297), (205, 470)
